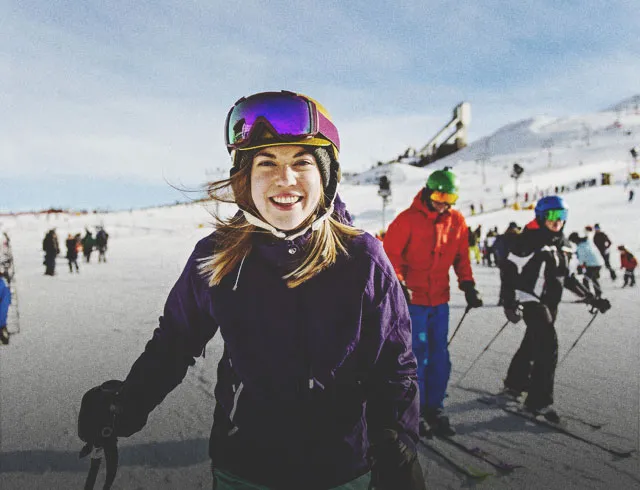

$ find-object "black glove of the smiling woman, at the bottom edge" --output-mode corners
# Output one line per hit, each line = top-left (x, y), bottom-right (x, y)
(369, 429), (427, 490)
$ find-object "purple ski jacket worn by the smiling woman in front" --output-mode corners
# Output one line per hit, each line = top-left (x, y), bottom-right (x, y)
(116, 197), (418, 489)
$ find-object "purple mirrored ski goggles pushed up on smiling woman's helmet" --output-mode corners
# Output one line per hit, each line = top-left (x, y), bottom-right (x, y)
(225, 90), (340, 152)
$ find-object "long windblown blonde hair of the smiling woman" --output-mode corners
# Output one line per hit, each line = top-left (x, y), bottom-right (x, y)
(199, 157), (362, 288)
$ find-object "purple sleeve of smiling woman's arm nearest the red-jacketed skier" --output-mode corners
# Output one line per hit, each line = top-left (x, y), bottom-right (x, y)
(364, 260), (420, 447)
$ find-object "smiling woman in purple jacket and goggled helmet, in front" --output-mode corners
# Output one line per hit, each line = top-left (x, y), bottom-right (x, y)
(79, 91), (425, 490)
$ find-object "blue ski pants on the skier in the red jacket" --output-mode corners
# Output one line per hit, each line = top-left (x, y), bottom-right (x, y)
(409, 303), (451, 413)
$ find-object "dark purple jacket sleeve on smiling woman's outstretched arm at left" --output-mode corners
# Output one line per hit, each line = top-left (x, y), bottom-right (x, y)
(116, 243), (217, 436)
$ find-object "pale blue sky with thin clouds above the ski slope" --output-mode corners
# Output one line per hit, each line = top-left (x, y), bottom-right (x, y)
(0, 0), (640, 211)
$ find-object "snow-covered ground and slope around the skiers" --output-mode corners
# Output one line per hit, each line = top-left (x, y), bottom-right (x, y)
(0, 98), (640, 490)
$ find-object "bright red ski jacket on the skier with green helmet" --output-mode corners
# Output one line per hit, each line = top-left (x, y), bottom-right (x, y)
(384, 191), (473, 306)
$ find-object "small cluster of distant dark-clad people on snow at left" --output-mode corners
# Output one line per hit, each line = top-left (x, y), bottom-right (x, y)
(42, 226), (109, 276)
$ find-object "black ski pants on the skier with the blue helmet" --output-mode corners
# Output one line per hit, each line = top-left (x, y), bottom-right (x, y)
(504, 303), (558, 409)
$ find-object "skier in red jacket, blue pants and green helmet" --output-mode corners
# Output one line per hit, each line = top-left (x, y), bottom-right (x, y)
(384, 168), (482, 436)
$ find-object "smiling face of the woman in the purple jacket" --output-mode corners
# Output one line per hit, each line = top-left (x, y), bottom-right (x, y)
(251, 145), (322, 231)
